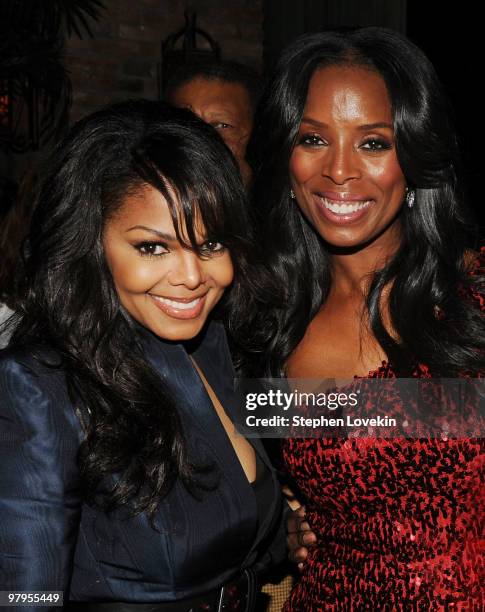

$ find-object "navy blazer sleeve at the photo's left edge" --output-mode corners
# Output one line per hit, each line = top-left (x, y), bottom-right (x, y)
(0, 356), (82, 611)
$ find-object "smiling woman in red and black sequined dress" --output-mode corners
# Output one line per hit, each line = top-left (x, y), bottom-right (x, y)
(248, 28), (485, 612)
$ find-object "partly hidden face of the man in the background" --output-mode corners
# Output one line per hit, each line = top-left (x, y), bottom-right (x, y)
(171, 78), (253, 182)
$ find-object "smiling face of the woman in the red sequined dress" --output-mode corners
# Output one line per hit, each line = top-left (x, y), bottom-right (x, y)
(289, 66), (406, 252)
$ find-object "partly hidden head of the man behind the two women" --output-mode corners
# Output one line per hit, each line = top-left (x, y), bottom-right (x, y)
(165, 61), (261, 184)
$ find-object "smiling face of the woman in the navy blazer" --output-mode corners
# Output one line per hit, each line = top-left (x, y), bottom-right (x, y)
(103, 185), (233, 341)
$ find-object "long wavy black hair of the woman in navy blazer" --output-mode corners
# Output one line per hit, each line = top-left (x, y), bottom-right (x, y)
(11, 100), (252, 516)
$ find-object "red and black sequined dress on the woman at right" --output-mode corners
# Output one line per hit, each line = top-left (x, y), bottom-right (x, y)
(283, 251), (485, 612)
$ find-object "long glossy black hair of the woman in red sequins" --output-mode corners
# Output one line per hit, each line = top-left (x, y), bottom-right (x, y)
(248, 27), (485, 376)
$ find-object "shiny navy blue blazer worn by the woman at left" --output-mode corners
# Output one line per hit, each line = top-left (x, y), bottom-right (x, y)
(0, 322), (285, 610)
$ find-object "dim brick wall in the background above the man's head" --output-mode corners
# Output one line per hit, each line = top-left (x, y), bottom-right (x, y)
(66, 0), (263, 120)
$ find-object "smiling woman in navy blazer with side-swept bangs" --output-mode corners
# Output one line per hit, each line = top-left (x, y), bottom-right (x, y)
(0, 101), (285, 611)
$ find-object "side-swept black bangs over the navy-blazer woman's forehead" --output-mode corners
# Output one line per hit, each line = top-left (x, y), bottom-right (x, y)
(129, 126), (247, 254)
